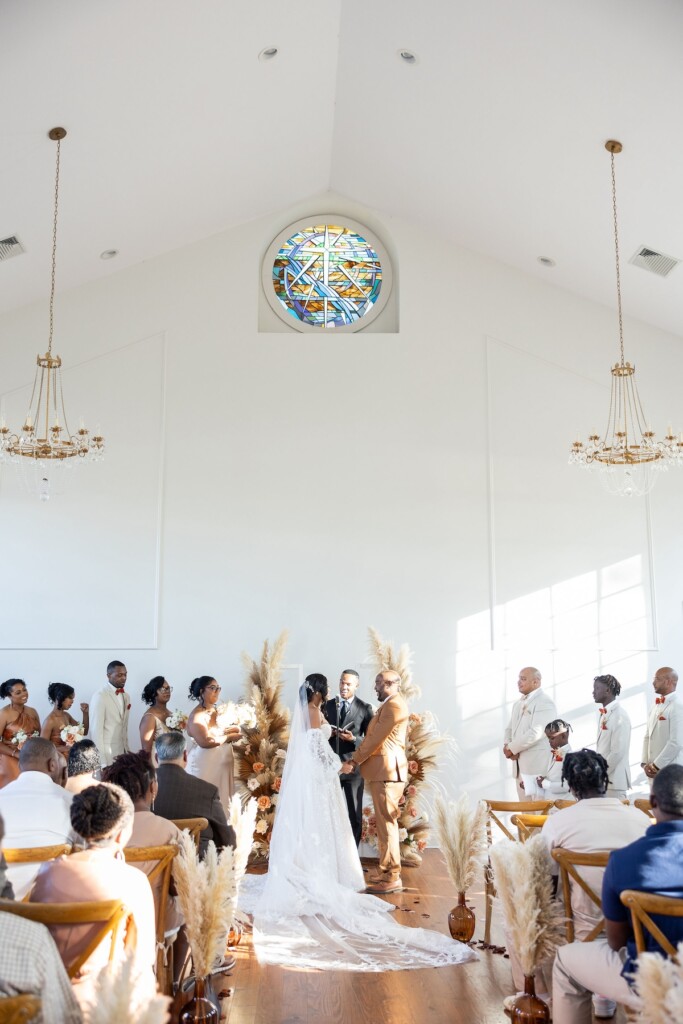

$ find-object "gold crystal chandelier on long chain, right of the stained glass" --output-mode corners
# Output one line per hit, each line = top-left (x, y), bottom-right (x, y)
(569, 139), (683, 497)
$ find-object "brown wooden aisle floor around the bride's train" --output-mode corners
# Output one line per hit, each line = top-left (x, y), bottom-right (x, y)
(222, 850), (513, 1024)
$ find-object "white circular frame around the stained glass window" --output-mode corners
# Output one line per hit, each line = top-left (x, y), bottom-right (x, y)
(261, 213), (393, 336)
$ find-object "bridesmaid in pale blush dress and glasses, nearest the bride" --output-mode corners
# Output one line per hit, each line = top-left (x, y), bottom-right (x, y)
(187, 676), (242, 817)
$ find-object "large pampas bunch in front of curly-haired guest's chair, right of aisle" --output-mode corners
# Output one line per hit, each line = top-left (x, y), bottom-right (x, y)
(490, 836), (564, 975)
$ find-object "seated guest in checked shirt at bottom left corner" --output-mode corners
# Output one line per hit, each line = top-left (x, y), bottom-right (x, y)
(0, 817), (83, 1024)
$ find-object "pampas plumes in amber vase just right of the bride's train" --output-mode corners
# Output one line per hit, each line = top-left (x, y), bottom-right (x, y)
(434, 794), (486, 893)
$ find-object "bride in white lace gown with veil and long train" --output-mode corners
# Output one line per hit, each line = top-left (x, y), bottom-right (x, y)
(241, 674), (476, 971)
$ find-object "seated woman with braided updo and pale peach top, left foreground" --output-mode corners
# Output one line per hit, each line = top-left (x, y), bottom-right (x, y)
(31, 782), (157, 1006)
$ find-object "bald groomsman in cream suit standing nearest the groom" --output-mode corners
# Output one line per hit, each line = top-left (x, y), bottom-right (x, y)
(503, 667), (557, 800)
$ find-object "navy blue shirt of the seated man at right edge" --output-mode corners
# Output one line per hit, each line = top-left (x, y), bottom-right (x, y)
(602, 820), (683, 976)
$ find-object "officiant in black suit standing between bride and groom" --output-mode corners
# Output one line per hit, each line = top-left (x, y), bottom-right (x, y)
(325, 669), (374, 846)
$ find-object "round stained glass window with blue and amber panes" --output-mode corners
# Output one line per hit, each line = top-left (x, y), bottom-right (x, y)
(263, 219), (390, 331)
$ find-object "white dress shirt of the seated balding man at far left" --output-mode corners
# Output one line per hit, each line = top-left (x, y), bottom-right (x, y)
(0, 771), (74, 899)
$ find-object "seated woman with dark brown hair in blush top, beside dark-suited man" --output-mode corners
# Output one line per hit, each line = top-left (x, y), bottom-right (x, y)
(102, 751), (182, 931)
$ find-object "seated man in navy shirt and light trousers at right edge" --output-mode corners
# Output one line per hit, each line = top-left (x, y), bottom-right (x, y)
(553, 764), (683, 1024)
